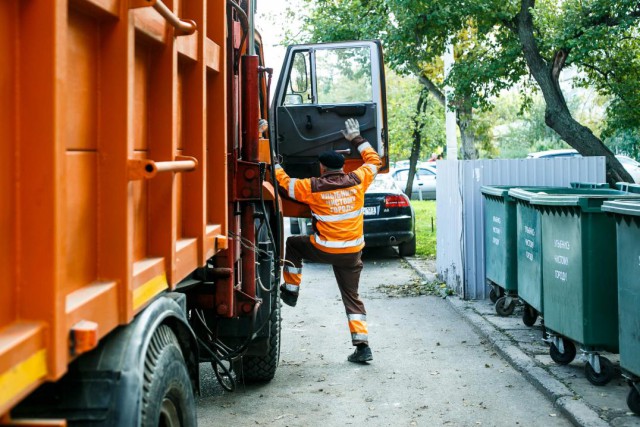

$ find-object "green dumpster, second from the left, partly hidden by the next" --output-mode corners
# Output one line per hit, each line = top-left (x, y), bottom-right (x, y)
(509, 186), (609, 326)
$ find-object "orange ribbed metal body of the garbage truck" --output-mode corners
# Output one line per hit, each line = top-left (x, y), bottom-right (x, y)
(0, 0), (274, 425)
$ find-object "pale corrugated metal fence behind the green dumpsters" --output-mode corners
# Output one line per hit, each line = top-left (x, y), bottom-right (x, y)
(436, 157), (605, 299)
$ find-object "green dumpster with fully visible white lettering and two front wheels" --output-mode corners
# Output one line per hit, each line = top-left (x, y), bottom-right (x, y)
(530, 189), (640, 385)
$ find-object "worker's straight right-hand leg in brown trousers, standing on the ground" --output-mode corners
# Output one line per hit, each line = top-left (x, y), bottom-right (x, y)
(333, 252), (369, 345)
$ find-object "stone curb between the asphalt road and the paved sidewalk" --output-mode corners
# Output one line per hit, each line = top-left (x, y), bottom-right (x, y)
(403, 258), (611, 427)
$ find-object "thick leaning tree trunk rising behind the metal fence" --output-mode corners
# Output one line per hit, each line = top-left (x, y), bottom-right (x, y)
(516, 0), (633, 185)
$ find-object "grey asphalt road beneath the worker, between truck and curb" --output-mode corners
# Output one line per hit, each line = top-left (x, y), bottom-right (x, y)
(198, 249), (571, 427)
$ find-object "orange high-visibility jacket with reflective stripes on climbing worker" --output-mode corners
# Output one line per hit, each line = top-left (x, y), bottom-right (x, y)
(275, 136), (381, 253)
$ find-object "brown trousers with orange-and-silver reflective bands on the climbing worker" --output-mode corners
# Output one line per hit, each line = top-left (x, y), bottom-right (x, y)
(284, 236), (368, 345)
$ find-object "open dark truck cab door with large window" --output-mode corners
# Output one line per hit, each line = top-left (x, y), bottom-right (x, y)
(271, 41), (389, 181)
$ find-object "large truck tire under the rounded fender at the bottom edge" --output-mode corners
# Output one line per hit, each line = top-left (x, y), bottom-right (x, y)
(140, 325), (197, 427)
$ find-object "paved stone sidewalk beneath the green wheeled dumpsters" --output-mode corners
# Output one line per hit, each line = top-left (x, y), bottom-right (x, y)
(406, 258), (640, 427)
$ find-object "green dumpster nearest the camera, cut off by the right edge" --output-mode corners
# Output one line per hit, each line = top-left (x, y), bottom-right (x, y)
(602, 200), (640, 415)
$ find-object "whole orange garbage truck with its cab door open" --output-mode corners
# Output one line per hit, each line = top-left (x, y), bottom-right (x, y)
(0, 0), (387, 426)
